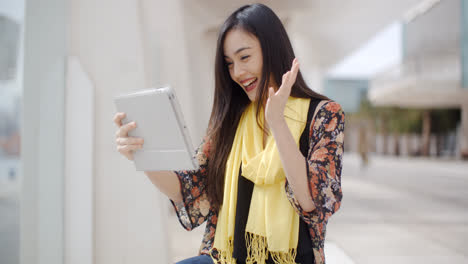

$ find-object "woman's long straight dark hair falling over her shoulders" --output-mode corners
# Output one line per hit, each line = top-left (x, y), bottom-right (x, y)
(206, 4), (328, 209)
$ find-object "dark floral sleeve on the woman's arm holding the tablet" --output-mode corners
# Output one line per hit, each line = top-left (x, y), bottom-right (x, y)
(171, 137), (211, 230)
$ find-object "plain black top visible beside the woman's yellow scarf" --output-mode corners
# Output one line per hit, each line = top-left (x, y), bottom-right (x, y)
(232, 99), (320, 264)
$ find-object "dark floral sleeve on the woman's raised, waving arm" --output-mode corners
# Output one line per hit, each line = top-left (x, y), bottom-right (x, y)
(286, 101), (345, 224)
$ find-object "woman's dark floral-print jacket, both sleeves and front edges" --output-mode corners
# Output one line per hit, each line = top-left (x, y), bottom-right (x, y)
(171, 101), (345, 264)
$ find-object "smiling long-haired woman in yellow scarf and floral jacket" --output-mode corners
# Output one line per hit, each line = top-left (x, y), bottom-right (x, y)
(114, 4), (345, 264)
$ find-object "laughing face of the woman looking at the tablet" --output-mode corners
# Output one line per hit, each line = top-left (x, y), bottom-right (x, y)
(223, 29), (271, 101)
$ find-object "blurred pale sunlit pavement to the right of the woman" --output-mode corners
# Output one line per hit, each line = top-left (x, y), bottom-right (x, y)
(327, 153), (468, 264)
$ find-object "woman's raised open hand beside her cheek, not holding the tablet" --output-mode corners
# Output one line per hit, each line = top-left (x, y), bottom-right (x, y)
(265, 58), (299, 127)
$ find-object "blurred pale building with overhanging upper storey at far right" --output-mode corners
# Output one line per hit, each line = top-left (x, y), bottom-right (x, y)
(369, 1), (468, 159)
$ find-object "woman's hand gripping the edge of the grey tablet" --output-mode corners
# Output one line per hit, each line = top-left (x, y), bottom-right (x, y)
(114, 113), (143, 160)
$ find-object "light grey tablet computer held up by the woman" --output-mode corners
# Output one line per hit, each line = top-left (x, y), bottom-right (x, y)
(114, 86), (198, 171)
